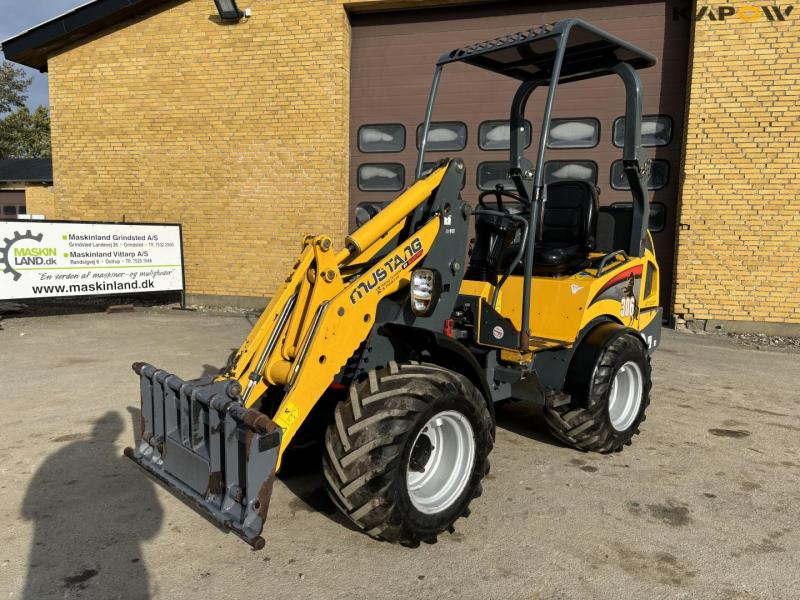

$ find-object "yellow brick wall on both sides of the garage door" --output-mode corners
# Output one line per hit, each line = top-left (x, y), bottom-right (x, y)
(42, 0), (800, 323)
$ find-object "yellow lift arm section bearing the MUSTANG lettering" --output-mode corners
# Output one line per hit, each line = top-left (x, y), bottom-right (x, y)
(230, 217), (441, 464)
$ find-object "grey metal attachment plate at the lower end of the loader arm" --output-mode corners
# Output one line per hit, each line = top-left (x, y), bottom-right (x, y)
(125, 363), (282, 550)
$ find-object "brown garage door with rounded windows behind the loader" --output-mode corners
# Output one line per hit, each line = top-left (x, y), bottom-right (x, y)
(350, 1), (689, 306)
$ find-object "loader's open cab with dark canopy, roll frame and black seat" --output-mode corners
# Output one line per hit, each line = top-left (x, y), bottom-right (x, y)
(416, 19), (656, 340)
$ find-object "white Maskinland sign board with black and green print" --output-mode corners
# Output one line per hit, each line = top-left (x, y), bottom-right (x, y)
(0, 221), (183, 300)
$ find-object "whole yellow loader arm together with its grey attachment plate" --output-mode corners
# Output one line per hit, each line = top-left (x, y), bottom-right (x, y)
(125, 161), (466, 548)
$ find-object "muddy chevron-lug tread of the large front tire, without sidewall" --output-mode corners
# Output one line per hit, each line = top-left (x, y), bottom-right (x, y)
(323, 363), (494, 546)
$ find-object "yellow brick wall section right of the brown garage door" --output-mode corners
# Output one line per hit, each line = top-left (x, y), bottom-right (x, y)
(674, 1), (800, 323)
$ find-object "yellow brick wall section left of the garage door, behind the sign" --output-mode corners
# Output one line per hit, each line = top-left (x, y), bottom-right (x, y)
(49, 0), (350, 297)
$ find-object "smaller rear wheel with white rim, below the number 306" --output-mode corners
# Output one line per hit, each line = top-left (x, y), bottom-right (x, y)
(544, 335), (651, 453)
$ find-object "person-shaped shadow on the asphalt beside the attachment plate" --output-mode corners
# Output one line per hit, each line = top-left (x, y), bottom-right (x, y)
(21, 409), (162, 600)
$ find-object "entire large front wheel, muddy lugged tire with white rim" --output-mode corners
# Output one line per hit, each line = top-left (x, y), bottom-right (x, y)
(323, 363), (493, 545)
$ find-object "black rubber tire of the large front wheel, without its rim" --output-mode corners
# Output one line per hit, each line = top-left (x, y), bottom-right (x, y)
(322, 363), (494, 546)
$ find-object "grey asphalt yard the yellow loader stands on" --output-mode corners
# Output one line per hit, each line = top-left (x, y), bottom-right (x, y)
(0, 309), (800, 600)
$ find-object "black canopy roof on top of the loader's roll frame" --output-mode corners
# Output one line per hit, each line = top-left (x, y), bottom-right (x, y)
(438, 19), (656, 83)
